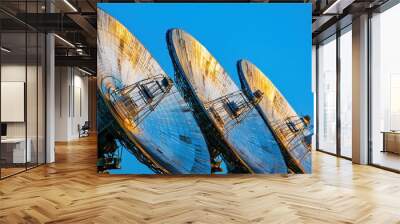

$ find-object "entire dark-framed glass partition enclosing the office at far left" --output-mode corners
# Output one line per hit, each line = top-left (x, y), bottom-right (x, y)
(0, 1), (46, 179)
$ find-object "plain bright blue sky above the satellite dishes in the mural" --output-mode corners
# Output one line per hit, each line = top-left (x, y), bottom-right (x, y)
(98, 3), (313, 117)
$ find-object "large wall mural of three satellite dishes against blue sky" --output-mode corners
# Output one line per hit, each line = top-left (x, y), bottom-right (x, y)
(97, 3), (313, 174)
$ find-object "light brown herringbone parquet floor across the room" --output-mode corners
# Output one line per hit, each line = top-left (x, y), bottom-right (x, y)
(0, 138), (400, 224)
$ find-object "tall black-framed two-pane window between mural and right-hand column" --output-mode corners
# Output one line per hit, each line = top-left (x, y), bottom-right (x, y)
(317, 25), (353, 159)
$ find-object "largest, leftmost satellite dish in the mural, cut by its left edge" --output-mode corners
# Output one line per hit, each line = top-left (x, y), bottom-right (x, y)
(97, 10), (211, 174)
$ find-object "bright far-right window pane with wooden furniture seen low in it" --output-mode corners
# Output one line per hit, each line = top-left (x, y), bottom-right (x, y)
(370, 4), (400, 171)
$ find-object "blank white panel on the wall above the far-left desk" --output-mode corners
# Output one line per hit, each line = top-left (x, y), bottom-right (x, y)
(1, 82), (25, 122)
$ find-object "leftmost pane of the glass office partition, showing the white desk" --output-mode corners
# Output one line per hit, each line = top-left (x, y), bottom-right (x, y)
(0, 32), (27, 177)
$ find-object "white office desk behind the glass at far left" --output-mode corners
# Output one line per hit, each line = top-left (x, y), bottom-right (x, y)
(1, 138), (32, 163)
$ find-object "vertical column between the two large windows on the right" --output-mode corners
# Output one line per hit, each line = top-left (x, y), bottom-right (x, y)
(352, 14), (368, 164)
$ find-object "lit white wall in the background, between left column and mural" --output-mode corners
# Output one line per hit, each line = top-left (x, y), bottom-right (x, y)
(55, 67), (88, 141)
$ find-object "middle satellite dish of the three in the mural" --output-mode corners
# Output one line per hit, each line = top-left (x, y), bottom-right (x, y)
(167, 29), (288, 173)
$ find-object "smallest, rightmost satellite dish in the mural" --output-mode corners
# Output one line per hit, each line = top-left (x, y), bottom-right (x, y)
(238, 60), (312, 173)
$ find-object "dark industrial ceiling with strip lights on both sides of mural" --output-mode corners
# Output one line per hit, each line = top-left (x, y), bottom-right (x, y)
(0, 0), (394, 72)
